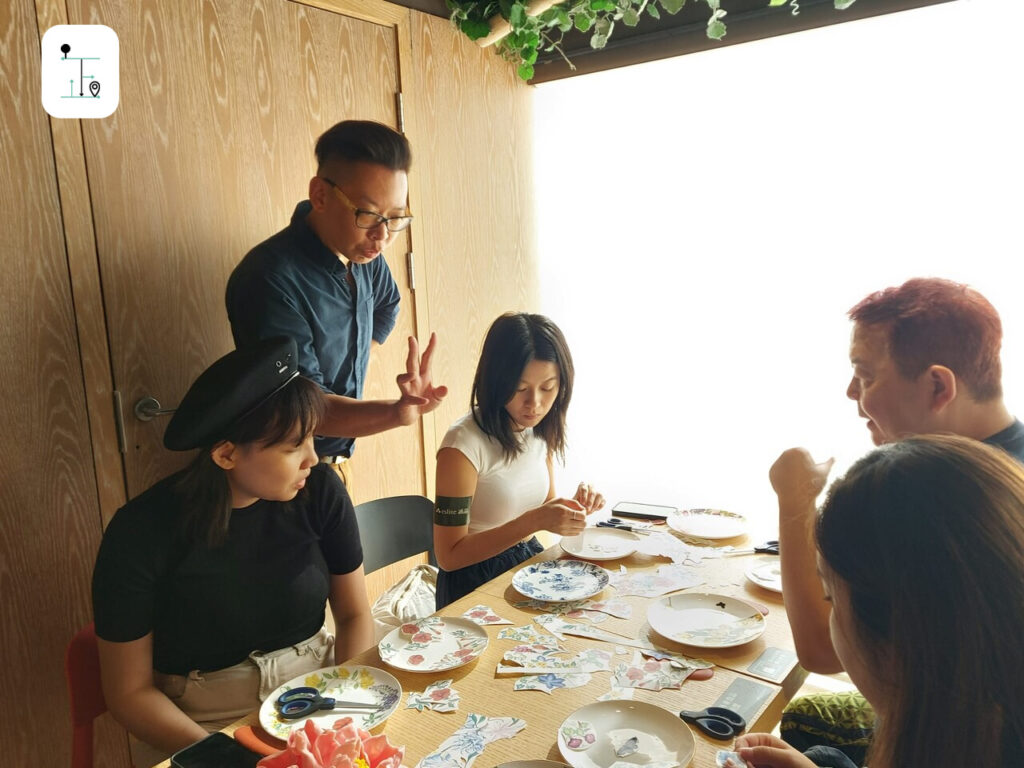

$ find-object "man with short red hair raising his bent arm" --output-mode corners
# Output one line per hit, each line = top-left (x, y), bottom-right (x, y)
(770, 278), (1024, 760)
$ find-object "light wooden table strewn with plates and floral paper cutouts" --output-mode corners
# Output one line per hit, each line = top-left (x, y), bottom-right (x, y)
(161, 541), (806, 768)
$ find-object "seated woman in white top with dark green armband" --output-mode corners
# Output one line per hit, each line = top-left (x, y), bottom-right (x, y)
(434, 312), (604, 609)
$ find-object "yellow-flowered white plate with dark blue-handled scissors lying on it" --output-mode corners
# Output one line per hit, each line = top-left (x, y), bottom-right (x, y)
(259, 665), (401, 740)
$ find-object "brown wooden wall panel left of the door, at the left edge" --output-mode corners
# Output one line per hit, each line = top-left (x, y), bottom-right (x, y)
(0, 0), (118, 766)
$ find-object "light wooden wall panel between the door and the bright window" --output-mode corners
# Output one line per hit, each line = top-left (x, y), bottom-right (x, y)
(408, 12), (540, 468)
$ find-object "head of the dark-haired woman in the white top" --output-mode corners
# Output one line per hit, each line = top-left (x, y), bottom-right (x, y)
(470, 312), (573, 458)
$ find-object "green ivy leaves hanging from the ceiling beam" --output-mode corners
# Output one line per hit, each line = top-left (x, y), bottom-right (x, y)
(445, 0), (855, 80)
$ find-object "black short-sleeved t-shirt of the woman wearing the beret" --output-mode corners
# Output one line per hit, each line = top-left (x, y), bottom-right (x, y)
(92, 465), (362, 675)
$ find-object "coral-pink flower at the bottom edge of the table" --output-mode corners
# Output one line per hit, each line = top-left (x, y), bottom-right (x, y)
(256, 718), (406, 768)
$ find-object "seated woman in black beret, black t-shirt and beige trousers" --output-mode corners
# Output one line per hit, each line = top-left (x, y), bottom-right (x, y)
(92, 337), (373, 768)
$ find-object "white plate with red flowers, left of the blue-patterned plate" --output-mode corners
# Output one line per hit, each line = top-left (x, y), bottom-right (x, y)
(377, 616), (487, 672)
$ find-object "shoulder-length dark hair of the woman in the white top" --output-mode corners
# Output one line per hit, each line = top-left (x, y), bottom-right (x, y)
(470, 312), (574, 460)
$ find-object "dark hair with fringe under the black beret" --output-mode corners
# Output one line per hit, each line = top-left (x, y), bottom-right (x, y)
(175, 376), (325, 548)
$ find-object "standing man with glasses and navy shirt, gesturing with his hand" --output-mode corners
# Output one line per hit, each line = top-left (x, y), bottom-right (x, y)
(226, 120), (447, 490)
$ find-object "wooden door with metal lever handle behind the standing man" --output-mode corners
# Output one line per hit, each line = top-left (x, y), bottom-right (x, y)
(69, 0), (424, 501)
